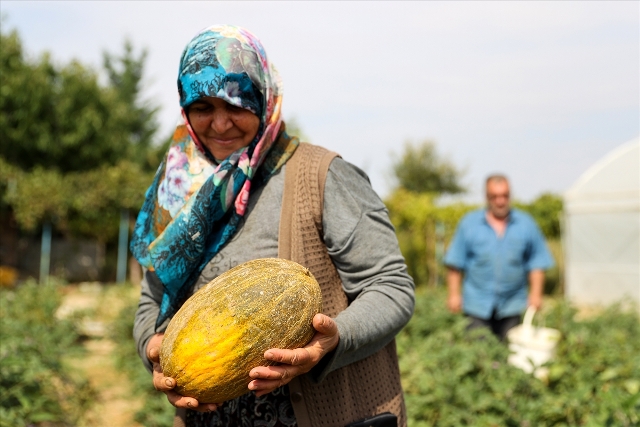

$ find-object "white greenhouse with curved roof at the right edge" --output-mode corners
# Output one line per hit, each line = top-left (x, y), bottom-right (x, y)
(563, 138), (640, 308)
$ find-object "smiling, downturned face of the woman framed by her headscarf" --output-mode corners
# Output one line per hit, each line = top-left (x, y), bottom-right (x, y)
(187, 96), (260, 160)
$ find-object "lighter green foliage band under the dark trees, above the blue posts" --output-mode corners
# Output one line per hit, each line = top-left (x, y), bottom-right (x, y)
(0, 158), (151, 242)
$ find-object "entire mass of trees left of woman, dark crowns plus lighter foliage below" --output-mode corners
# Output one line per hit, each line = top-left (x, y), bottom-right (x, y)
(0, 26), (164, 241)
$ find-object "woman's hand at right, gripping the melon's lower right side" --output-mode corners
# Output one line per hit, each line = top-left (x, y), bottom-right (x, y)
(249, 313), (340, 396)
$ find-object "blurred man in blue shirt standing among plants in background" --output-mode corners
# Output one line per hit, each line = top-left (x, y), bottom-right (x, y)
(444, 175), (553, 340)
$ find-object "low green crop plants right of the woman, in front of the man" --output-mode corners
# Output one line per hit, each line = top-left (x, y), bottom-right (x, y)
(397, 289), (640, 427)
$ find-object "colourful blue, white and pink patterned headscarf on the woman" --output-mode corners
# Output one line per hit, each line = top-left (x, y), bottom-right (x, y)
(131, 25), (298, 326)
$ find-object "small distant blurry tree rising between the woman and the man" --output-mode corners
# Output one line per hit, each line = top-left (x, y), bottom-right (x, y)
(393, 141), (465, 194)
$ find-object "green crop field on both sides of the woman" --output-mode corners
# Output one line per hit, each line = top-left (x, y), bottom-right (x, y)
(0, 283), (640, 427)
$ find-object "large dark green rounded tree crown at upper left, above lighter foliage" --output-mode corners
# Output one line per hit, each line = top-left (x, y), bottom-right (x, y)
(0, 31), (130, 173)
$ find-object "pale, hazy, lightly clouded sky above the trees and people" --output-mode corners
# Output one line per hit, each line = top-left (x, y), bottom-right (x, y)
(0, 0), (640, 202)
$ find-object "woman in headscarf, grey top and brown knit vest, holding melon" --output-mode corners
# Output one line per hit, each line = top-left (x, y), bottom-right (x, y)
(131, 26), (414, 426)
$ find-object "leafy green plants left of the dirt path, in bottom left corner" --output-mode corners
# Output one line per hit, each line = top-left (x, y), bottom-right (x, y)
(0, 281), (95, 427)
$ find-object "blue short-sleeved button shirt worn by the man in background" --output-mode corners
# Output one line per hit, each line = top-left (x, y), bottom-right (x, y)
(444, 209), (554, 319)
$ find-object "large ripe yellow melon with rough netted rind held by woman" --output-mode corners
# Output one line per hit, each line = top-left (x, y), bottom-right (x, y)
(160, 258), (322, 403)
